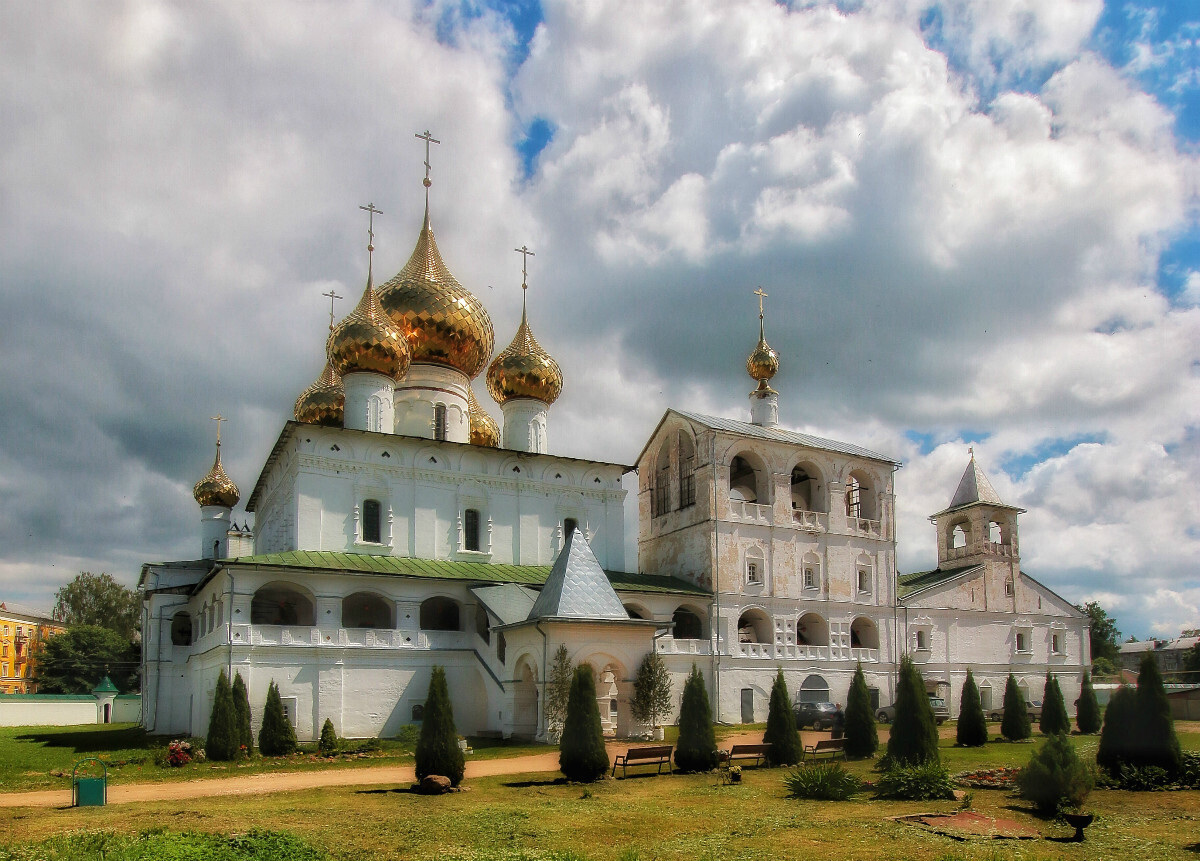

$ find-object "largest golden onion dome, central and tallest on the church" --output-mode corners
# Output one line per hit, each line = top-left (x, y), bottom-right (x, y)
(379, 203), (496, 379)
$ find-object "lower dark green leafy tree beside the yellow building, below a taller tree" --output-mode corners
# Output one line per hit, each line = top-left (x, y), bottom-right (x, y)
(34, 625), (142, 693)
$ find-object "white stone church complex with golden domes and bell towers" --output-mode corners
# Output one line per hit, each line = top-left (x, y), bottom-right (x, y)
(139, 165), (1091, 739)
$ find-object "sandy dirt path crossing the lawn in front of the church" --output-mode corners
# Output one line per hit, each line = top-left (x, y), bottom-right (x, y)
(0, 731), (772, 807)
